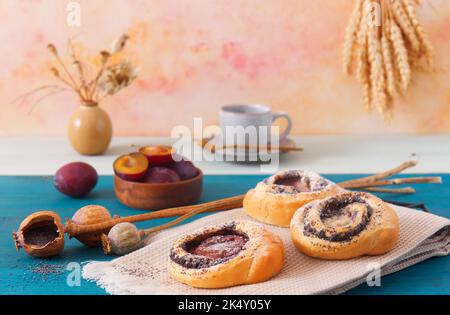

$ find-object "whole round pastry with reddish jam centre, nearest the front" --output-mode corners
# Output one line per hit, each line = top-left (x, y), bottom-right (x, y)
(169, 221), (284, 288)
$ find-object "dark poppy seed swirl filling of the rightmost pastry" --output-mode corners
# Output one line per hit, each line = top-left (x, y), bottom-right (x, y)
(303, 196), (373, 242)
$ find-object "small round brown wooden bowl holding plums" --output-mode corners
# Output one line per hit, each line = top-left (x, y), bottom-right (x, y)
(114, 151), (203, 210)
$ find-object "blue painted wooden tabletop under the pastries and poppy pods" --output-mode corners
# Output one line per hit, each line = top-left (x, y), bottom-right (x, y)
(0, 175), (450, 294)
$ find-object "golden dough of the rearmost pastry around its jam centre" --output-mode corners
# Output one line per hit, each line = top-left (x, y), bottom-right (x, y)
(243, 171), (345, 227)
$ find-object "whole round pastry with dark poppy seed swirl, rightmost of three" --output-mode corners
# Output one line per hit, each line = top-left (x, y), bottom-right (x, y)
(290, 192), (399, 260)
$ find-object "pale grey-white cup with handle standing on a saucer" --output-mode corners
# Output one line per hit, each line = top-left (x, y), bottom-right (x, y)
(220, 104), (292, 145)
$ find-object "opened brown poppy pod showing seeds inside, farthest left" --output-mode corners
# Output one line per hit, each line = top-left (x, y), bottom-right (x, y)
(13, 211), (64, 258)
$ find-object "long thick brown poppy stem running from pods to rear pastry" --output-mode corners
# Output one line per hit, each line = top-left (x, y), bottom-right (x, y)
(64, 195), (244, 237)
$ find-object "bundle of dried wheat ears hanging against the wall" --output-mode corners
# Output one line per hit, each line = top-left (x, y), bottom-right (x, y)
(343, 0), (434, 121)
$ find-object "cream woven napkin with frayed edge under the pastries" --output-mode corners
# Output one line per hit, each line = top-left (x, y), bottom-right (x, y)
(83, 206), (450, 295)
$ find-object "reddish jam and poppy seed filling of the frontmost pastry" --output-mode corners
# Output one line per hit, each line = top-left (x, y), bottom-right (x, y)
(170, 227), (248, 269)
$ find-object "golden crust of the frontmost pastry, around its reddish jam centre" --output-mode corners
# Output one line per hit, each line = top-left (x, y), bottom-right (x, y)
(169, 221), (284, 288)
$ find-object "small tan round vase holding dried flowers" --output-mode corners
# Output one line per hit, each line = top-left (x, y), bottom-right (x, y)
(13, 34), (137, 155)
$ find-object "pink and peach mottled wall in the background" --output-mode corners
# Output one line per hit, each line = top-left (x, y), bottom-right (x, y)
(0, 0), (450, 135)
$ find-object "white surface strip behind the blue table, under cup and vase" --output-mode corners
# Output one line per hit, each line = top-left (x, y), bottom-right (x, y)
(0, 135), (450, 175)
